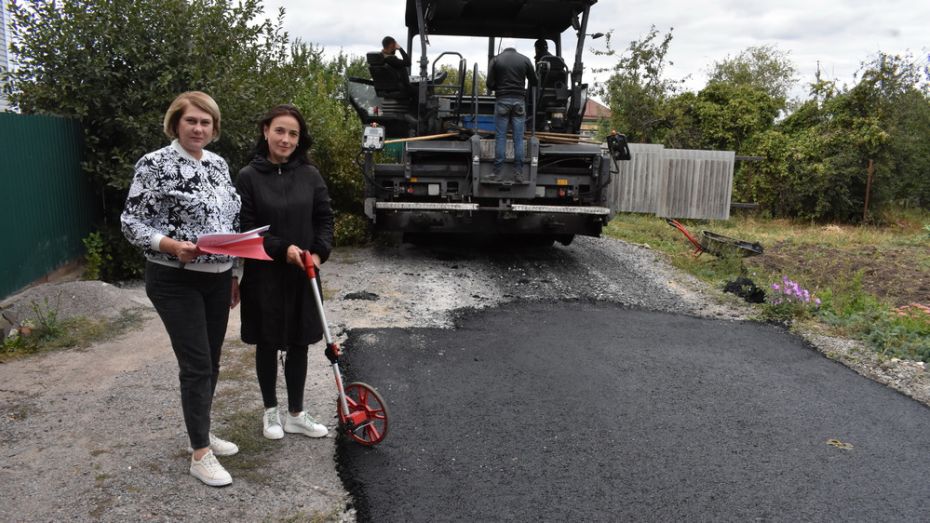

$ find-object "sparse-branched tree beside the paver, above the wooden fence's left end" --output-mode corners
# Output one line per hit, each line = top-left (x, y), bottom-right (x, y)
(595, 26), (681, 143)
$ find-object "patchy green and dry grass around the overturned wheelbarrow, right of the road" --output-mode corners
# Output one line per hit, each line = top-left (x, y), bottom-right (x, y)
(605, 211), (930, 363)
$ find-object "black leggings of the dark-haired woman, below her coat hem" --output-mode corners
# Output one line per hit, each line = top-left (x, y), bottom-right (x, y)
(255, 343), (309, 412)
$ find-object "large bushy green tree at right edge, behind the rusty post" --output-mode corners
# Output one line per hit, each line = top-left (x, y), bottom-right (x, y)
(737, 53), (930, 222)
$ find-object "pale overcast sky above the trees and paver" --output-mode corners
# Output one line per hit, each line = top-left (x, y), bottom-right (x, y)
(264, 0), (930, 100)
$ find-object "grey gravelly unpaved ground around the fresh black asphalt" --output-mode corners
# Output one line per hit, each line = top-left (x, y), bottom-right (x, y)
(0, 238), (930, 521)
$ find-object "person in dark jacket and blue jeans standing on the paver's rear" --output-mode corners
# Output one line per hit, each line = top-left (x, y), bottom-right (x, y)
(485, 47), (537, 183)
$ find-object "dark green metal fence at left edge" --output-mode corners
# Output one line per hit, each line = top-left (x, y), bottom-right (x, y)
(0, 113), (99, 299)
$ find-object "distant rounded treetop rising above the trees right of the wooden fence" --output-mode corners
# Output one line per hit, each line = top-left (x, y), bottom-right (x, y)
(708, 45), (797, 103)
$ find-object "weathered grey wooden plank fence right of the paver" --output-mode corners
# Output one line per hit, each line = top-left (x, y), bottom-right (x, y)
(608, 144), (736, 220)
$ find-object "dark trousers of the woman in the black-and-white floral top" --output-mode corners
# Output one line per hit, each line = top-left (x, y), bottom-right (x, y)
(145, 262), (232, 449)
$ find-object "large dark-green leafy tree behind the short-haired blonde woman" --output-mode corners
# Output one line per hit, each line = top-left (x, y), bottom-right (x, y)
(9, 0), (300, 219)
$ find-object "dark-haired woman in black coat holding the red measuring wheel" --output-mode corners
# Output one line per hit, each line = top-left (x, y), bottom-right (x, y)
(236, 105), (333, 439)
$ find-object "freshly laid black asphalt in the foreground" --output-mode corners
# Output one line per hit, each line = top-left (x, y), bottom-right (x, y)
(338, 302), (930, 522)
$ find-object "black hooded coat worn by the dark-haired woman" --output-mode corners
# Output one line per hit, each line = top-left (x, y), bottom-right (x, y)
(236, 157), (334, 349)
